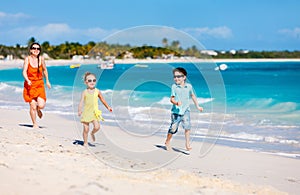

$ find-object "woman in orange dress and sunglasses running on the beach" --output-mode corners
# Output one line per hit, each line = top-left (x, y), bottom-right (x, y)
(23, 43), (51, 128)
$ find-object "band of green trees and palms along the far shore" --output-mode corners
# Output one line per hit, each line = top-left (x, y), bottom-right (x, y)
(0, 37), (300, 59)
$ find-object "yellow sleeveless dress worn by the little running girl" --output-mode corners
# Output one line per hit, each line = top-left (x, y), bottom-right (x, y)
(81, 89), (104, 123)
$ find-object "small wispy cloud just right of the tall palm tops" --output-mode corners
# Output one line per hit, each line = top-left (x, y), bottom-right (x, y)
(184, 26), (233, 39)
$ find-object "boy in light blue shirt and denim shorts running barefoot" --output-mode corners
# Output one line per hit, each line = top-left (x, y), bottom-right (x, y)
(165, 67), (203, 151)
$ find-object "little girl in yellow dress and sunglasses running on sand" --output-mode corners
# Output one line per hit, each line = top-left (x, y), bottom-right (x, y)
(78, 72), (112, 146)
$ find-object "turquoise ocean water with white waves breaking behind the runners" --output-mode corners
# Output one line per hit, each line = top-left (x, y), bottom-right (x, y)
(0, 62), (300, 158)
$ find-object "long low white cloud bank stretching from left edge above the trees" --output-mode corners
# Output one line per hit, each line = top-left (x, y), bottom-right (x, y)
(0, 23), (232, 48)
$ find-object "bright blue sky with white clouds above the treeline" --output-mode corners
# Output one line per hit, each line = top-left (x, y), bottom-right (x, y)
(0, 0), (300, 51)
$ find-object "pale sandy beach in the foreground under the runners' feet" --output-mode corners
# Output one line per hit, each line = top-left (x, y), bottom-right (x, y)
(0, 109), (300, 195)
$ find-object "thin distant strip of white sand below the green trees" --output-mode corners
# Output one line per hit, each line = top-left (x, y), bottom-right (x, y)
(0, 58), (300, 70)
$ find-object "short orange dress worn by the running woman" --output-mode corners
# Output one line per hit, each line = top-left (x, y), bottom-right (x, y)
(23, 63), (46, 102)
